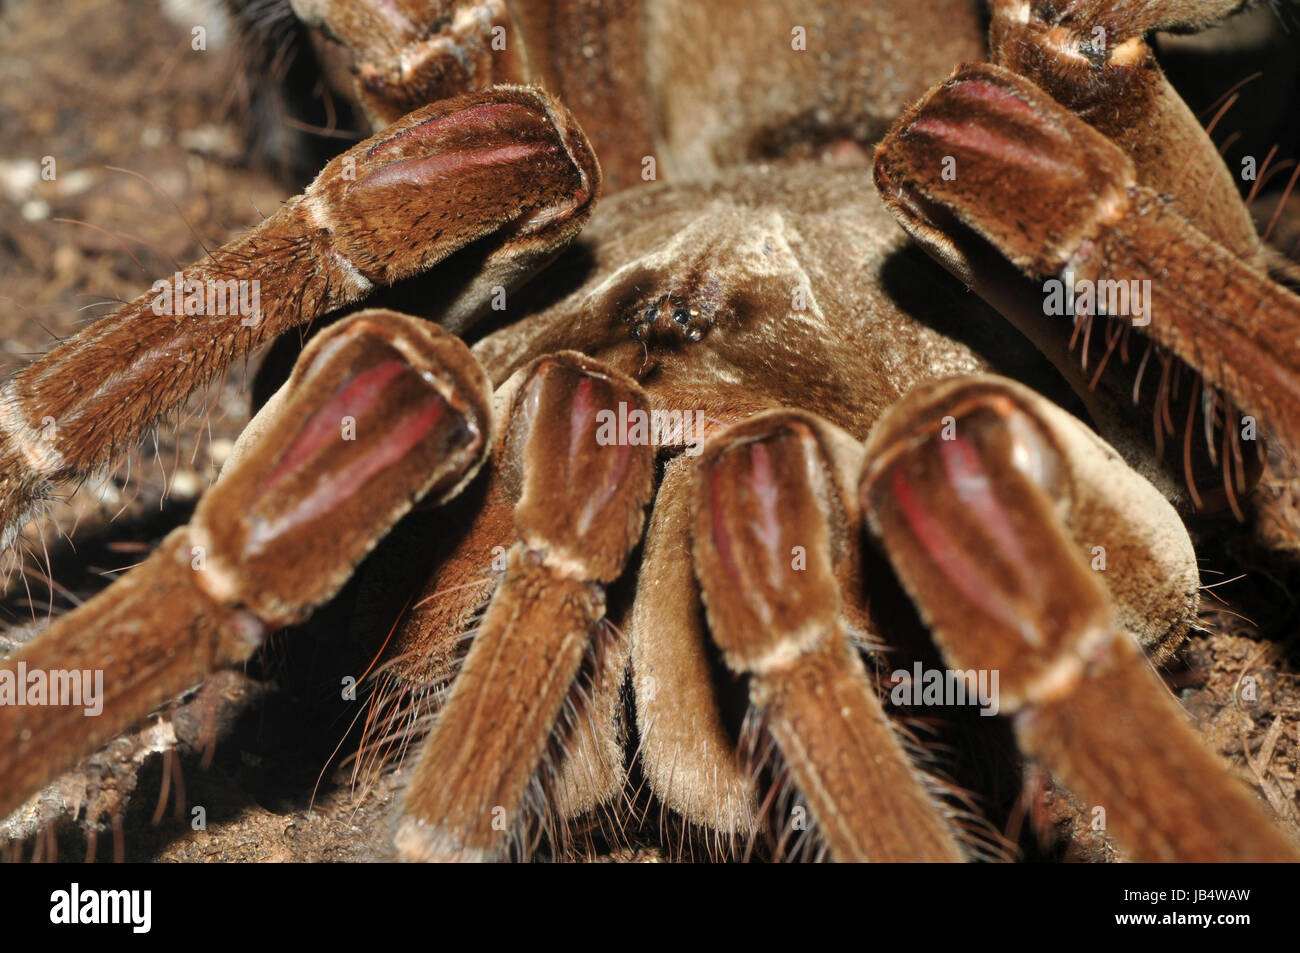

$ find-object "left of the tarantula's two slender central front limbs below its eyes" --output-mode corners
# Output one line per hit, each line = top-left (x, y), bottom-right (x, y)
(397, 352), (654, 859)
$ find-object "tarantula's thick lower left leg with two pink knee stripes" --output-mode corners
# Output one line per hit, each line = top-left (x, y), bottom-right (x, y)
(0, 311), (490, 816)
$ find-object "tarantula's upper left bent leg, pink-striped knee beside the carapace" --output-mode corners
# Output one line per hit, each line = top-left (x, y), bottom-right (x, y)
(0, 87), (599, 545)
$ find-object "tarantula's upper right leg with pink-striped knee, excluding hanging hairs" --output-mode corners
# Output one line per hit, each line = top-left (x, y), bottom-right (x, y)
(875, 64), (1300, 465)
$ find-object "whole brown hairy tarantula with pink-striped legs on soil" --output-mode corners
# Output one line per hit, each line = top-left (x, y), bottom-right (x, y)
(0, 0), (1300, 861)
